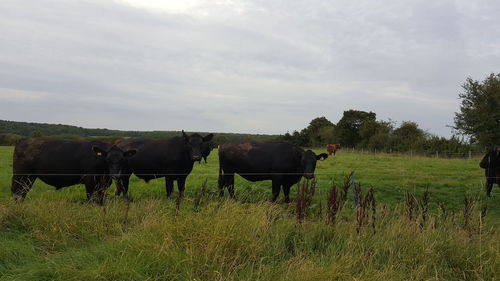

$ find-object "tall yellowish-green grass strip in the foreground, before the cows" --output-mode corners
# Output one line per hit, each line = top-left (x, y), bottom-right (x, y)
(0, 190), (500, 280)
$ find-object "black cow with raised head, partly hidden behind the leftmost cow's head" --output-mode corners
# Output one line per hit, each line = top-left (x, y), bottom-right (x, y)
(116, 131), (213, 197)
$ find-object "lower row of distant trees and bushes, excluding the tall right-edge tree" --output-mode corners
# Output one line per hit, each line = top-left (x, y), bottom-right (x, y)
(278, 110), (476, 157)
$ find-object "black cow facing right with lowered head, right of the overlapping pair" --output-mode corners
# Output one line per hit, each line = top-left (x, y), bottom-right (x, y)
(219, 141), (328, 203)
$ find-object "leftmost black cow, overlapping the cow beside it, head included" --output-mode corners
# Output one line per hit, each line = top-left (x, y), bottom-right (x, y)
(11, 139), (135, 204)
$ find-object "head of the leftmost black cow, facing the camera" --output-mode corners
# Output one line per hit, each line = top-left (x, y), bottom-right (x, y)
(92, 145), (137, 178)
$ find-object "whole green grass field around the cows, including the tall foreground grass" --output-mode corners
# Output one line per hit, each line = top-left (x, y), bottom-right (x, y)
(0, 147), (500, 280)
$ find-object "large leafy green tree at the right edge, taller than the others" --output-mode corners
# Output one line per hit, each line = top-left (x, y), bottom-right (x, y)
(454, 73), (500, 146)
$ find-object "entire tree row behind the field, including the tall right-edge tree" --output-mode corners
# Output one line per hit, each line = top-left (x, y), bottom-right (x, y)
(279, 73), (500, 156)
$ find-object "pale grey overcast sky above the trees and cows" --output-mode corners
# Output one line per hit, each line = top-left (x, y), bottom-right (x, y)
(0, 0), (500, 136)
